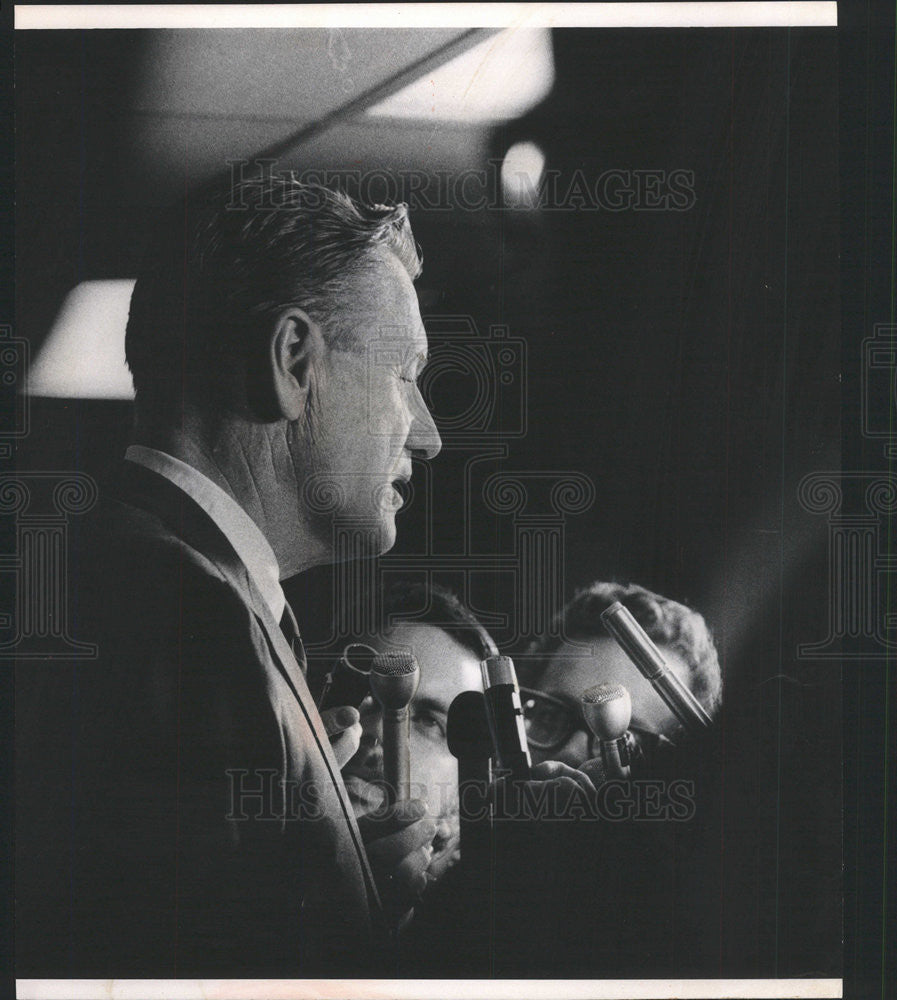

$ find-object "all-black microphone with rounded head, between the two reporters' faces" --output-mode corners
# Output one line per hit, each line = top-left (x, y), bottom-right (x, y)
(446, 691), (492, 871)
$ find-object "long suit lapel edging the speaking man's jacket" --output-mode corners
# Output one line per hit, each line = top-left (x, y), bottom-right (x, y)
(114, 461), (381, 909)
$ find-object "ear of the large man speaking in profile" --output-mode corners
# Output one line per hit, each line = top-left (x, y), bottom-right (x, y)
(267, 306), (324, 420)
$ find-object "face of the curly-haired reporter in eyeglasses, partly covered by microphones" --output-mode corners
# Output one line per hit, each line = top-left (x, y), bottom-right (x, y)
(532, 637), (689, 767)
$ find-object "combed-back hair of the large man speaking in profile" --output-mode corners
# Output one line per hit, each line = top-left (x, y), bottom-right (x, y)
(125, 175), (421, 417)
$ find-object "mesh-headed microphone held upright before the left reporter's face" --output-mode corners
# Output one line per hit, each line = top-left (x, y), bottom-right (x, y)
(370, 652), (420, 806)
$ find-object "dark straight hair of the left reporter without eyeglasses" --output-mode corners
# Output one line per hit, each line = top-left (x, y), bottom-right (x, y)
(382, 580), (498, 660)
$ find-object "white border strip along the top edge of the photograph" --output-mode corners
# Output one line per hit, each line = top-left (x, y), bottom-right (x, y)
(15, 0), (838, 30)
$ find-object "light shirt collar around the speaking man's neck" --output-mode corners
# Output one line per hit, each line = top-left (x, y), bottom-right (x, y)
(125, 444), (286, 622)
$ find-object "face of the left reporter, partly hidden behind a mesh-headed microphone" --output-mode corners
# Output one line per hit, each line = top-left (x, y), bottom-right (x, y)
(343, 625), (482, 880)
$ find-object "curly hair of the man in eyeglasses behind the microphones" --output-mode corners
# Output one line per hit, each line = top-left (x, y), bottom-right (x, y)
(521, 581), (723, 715)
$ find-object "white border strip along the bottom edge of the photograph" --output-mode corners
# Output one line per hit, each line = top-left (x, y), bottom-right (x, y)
(16, 979), (844, 1000)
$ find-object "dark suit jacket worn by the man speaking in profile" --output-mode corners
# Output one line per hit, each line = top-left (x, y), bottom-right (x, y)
(18, 462), (381, 978)
